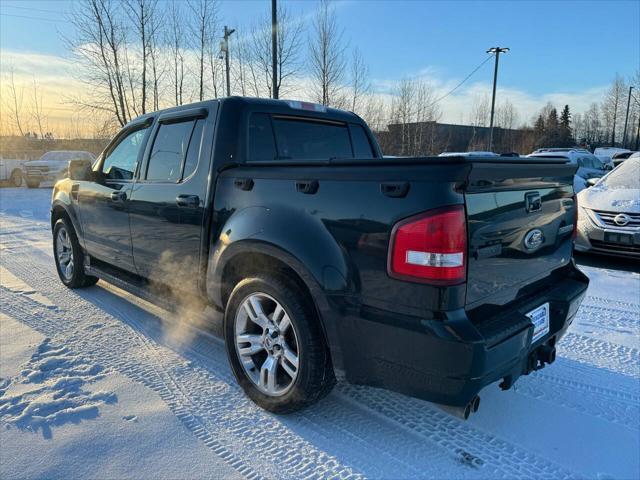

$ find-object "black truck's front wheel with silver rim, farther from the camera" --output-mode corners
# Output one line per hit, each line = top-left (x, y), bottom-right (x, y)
(53, 218), (98, 288)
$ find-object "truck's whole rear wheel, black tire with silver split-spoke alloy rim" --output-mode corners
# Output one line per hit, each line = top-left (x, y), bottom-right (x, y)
(224, 276), (335, 413)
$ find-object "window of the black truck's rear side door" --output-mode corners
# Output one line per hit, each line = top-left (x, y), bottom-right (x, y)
(146, 120), (195, 183)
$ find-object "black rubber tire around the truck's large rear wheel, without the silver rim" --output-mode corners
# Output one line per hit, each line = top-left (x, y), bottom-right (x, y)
(224, 275), (336, 413)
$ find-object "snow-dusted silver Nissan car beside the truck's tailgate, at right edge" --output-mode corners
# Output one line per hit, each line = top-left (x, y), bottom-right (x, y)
(576, 157), (640, 258)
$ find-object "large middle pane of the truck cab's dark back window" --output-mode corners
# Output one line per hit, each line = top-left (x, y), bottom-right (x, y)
(272, 116), (353, 160)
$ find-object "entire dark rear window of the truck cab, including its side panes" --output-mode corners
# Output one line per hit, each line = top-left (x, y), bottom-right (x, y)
(248, 113), (375, 161)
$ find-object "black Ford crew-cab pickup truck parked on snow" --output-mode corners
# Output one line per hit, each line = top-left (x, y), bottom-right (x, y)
(51, 97), (588, 416)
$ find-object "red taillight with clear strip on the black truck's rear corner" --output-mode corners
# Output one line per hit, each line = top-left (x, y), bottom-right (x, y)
(387, 205), (467, 285)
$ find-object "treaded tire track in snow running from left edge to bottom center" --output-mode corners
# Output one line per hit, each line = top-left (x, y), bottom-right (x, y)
(0, 288), (358, 478)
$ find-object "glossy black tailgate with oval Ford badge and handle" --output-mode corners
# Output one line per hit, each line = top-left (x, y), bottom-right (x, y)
(465, 158), (577, 308)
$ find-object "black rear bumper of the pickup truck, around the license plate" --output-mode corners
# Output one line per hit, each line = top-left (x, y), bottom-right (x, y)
(342, 265), (589, 406)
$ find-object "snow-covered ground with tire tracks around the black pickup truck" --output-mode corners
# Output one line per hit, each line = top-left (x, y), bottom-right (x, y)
(0, 188), (640, 479)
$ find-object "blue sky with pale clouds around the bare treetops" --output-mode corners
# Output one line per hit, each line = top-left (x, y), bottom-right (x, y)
(0, 0), (640, 135)
